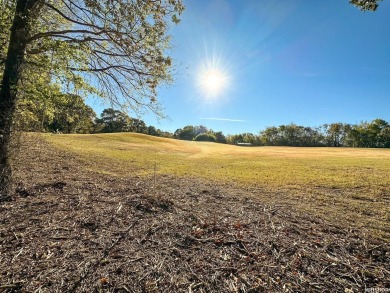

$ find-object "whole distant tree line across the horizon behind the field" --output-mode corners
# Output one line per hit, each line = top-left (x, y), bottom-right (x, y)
(18, 96), (390, 148)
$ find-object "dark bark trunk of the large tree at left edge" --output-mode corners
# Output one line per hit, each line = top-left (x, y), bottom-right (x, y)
(0, 0), (39, 201)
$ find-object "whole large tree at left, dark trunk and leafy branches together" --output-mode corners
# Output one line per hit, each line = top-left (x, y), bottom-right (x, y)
(0, 0), (184, 198)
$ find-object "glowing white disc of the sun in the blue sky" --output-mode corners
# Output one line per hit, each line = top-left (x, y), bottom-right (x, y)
(199, 68), (228, 98)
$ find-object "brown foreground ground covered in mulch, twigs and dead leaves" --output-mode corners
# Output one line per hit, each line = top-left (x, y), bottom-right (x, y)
(0, 137), (390, 292)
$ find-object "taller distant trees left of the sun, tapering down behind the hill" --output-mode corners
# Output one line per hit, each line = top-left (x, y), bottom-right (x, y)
(17, 93), (173, 137)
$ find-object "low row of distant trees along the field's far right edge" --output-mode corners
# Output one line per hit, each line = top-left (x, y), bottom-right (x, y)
(174, 119), (390, 148)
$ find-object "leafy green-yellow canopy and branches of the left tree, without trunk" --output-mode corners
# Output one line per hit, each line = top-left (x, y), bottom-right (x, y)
(2, 0), (184, 115)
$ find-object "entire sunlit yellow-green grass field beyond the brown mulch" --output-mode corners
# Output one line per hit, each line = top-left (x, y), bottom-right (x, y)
(45, 133), (390, 239)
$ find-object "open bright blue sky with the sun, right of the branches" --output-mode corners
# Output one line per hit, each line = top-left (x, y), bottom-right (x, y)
(88, 0), (390, 134)
